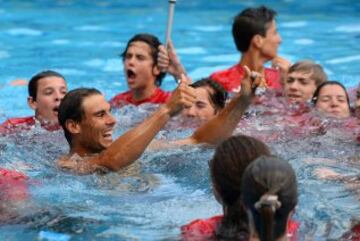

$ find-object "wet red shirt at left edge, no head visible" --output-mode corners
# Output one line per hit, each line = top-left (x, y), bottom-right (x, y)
(0, 168), (28, 201)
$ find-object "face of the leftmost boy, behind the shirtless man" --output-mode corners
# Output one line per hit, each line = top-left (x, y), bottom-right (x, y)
(28, 76), (67, 124)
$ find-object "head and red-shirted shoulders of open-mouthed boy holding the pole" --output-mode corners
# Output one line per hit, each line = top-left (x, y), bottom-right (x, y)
(110, 33), (170, 107)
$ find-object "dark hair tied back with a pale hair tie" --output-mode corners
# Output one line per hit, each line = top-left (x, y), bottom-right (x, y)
(241, 156), (298, 241)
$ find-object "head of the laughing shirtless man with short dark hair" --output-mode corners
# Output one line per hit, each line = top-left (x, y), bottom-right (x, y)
(59, 88), (116, 153)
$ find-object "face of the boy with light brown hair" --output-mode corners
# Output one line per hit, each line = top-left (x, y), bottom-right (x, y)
(283, 71), (317, 103)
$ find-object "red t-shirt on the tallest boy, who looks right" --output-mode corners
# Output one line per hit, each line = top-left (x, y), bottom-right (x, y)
(210, 64), (281, 92)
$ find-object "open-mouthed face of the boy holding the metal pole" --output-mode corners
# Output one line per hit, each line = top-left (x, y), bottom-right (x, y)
(124, 41), (160, 90)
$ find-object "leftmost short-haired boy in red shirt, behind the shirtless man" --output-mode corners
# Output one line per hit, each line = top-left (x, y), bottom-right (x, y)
(0, 70), (67, 133)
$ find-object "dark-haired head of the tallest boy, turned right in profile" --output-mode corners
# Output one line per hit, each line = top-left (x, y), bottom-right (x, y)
(232, 6), (281, 60)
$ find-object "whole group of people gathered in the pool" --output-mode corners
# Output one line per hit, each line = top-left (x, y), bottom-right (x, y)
(0, 6), (360, 241)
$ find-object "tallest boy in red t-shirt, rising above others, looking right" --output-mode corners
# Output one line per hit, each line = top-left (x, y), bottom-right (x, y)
(210, 6), (290, 92)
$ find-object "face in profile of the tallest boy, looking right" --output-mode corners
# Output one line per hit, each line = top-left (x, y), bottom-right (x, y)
(261, 20), (282, 60)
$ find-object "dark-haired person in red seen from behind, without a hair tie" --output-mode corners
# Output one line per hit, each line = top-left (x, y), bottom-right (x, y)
(181, 135), (299, 241)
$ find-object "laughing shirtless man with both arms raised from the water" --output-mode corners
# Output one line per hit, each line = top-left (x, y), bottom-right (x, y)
(58, 69), (254, 174)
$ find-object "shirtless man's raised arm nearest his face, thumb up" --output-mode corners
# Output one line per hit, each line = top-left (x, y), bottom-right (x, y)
(89, 83), (196, 170)
